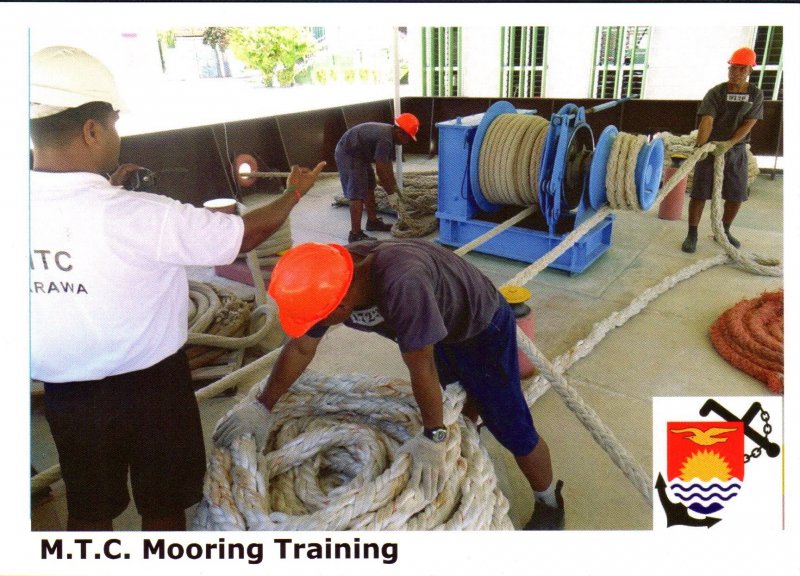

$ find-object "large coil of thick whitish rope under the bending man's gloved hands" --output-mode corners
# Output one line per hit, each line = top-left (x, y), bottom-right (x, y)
(192, 372), (513, 531)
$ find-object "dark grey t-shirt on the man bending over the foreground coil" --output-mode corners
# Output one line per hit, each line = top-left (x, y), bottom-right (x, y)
(308, 239), (500, 352)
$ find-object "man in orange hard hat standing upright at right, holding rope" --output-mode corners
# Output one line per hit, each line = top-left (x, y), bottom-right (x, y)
(681, 48), (764, 253)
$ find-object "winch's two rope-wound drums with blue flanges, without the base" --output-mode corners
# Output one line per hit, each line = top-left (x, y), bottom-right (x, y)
(471, 98), (664, 234)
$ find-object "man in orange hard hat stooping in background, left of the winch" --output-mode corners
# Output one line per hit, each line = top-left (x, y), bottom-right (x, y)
(334, 112), (419, 242)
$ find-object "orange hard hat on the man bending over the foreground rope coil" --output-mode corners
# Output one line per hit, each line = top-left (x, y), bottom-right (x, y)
(269, 242), (353, 338)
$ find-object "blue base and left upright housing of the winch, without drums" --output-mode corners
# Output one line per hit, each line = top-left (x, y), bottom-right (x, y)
(436, 114), (615, 274)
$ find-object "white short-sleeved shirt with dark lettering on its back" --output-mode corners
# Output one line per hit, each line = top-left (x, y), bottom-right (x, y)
(30, 171), (244, 382)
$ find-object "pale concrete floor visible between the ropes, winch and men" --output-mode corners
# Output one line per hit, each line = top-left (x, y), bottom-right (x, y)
(31, 158), (783, 530)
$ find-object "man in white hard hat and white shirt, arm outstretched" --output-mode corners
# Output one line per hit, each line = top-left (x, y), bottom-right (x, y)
(30, 46), (325, 530)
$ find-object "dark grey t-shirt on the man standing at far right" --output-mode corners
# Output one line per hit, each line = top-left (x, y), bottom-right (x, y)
(697, 82), (764, 142)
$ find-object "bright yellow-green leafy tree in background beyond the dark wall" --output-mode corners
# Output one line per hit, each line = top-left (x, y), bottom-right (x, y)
(227, 26), (316, 86)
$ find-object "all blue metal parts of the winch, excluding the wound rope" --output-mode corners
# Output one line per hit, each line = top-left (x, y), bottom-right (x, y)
(436, 100), (663, 274)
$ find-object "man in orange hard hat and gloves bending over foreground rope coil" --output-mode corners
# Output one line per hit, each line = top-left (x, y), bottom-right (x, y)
(214, 239), (564, 530)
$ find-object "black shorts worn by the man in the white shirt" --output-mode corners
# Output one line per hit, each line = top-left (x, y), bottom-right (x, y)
(44, 350), (206, 521)
